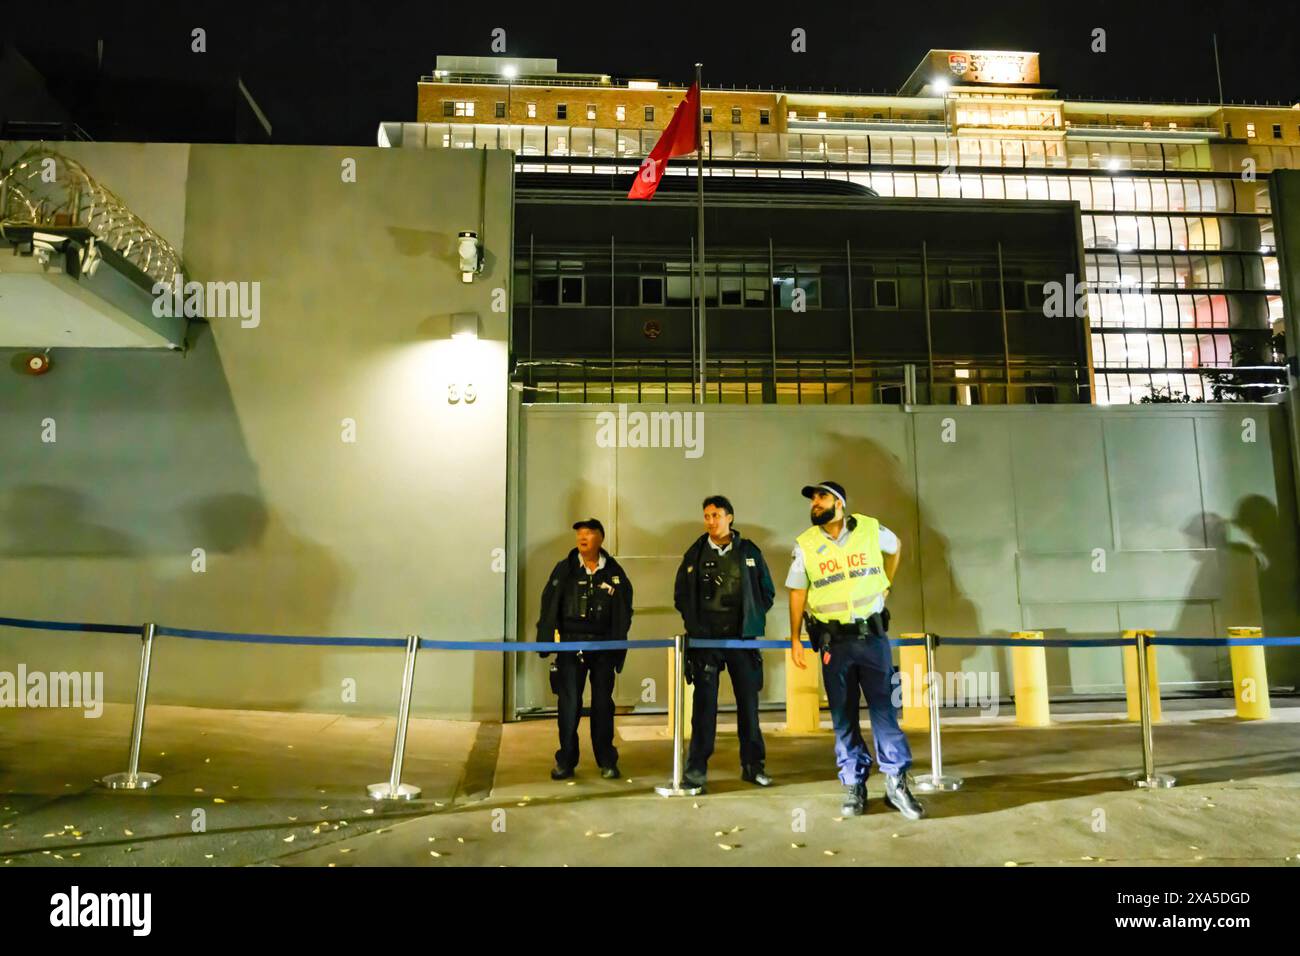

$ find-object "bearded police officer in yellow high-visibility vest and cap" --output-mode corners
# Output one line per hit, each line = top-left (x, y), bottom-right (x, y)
(785, 481), (926, 819)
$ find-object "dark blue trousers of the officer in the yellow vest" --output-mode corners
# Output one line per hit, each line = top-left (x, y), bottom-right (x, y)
(819, 635), (911, 784)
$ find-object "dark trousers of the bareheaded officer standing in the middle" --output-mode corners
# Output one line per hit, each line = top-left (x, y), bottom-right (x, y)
(686, 648), (767, 777)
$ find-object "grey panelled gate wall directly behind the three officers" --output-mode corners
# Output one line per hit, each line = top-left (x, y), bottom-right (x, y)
(517, 405), (1300, 709)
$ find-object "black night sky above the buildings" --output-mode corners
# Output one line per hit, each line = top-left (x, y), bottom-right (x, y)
(3, 0), (1300, 146)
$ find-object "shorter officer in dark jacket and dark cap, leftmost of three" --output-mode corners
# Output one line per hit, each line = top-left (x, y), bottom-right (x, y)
(537, 518), (632, 780)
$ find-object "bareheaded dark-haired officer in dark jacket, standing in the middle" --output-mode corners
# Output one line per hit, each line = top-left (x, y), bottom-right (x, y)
(673, 494), (776, 788)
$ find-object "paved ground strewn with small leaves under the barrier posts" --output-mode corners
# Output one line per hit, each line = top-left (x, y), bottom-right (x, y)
(0, 700), (1300, 866)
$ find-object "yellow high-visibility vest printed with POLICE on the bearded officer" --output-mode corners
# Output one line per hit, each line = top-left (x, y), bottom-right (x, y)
(796, 514), (889, 624)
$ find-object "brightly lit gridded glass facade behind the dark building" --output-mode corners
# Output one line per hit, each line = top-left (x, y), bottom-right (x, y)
(391, 119), (1300, 403)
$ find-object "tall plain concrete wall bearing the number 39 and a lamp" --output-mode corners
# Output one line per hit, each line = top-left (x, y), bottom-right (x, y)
(0, 143), (512, 717)
